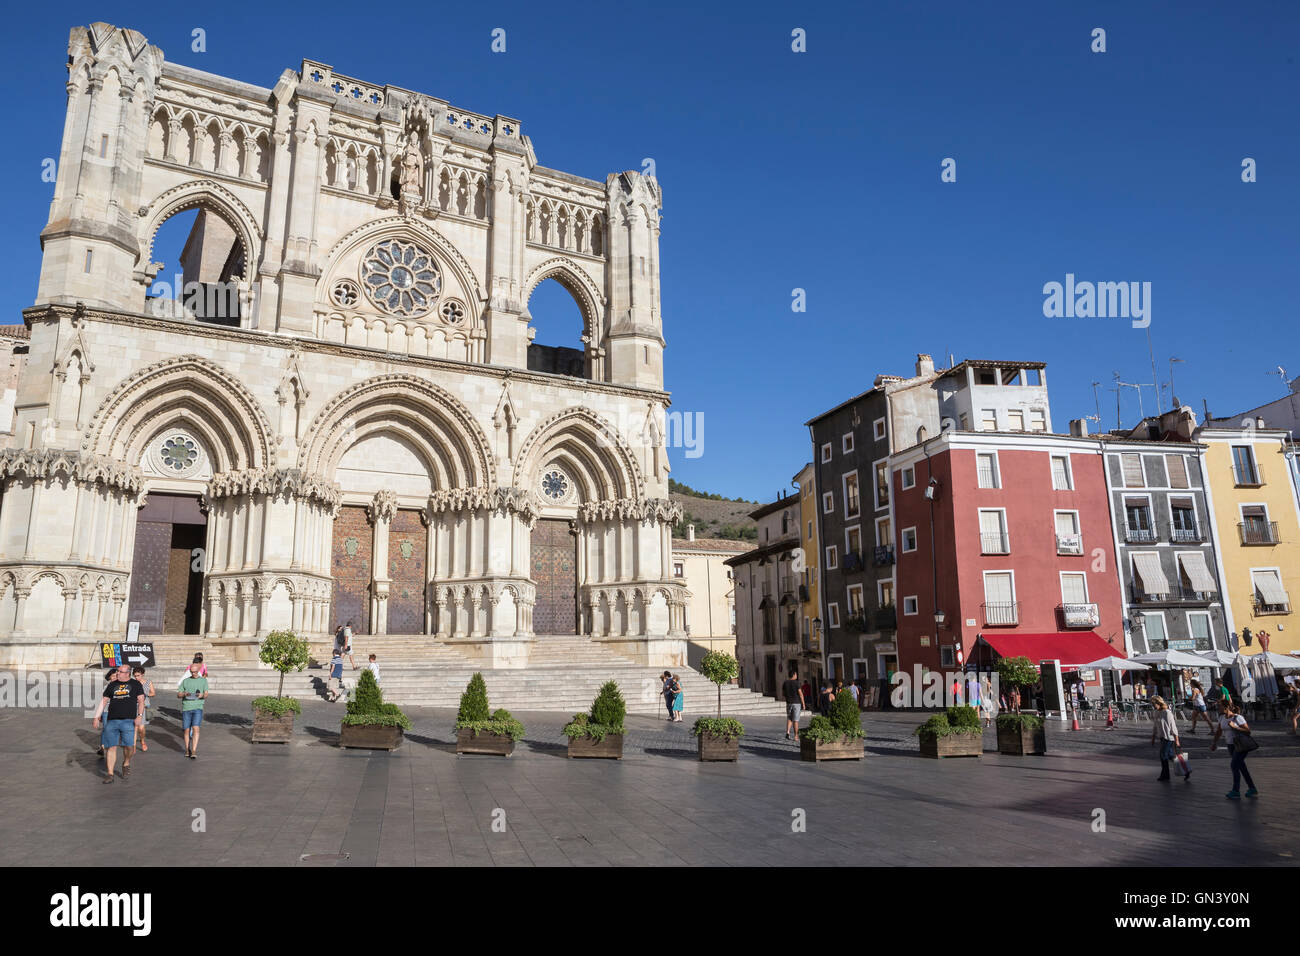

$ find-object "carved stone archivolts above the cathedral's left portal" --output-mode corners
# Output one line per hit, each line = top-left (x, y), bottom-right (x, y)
(82, 355), (273, 472)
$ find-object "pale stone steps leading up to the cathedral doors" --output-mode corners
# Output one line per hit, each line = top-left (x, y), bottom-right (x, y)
(139, 635), (785, 718)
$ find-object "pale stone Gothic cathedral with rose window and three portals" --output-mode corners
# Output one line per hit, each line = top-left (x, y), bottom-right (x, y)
(0, 23), (688, 667)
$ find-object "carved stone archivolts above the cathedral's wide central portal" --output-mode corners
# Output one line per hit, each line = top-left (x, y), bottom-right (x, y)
(300, 375), (497, 488)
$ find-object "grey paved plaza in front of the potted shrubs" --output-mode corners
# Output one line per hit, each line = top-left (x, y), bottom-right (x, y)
(0, 697), (1300, 866)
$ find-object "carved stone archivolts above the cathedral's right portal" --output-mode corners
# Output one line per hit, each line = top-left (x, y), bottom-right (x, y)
(514, 407), (645, 501)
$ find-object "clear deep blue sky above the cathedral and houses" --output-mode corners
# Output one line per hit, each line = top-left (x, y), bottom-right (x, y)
(0, 0), (1300, 499)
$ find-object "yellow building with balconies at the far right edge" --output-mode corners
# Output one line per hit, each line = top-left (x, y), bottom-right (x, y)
(1195, 423), (1300, 654)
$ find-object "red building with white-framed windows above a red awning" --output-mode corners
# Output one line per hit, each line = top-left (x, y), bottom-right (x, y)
(891, 431), (1125, 672)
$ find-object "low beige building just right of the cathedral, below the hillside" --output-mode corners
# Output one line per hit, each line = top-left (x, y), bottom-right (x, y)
(672, 524), (750, 667)
